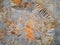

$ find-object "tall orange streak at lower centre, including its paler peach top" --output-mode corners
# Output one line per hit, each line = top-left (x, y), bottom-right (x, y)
(25, 22), (34, 40)
